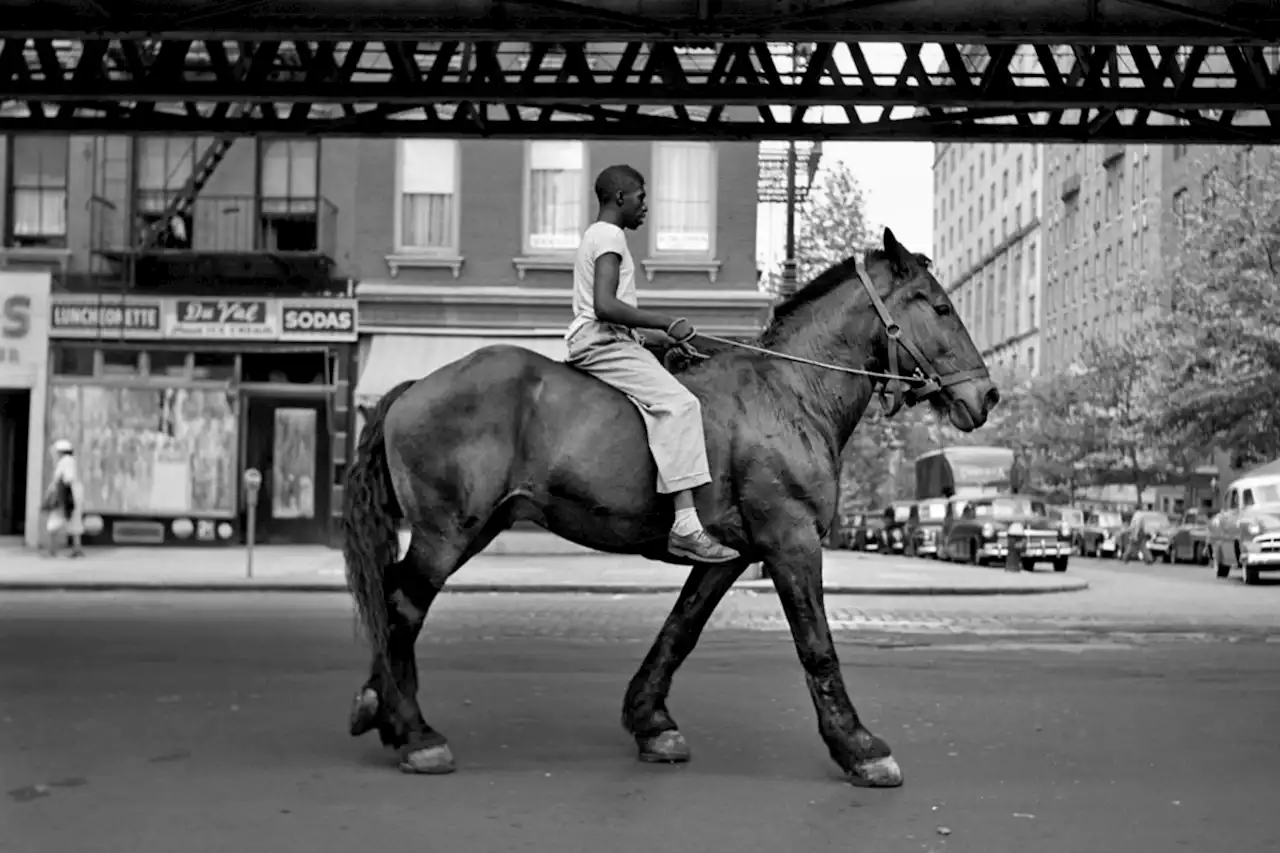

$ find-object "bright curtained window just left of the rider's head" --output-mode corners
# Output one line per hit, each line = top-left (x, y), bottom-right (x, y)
(526, 140), (586, 254)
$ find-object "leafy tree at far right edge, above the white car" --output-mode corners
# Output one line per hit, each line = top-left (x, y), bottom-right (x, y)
(1147, 149), (1280, 464)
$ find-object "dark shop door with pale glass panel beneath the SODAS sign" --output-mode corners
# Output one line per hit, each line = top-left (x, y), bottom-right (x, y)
(244, 397), (332, 544)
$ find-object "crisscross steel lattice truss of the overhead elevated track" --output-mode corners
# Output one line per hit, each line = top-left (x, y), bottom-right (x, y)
(0, 38), (1280, 143)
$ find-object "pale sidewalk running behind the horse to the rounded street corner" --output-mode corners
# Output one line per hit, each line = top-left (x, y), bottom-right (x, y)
(0, 533), (1088, 596)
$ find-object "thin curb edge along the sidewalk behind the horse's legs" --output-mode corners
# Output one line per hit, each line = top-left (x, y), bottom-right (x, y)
(0, 580), (1089, 596)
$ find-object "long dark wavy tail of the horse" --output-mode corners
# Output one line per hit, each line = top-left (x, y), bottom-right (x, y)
(342, 379), (416, 656)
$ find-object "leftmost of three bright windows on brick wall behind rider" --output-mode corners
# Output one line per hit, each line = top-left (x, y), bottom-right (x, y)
(397, 140), (460, 254)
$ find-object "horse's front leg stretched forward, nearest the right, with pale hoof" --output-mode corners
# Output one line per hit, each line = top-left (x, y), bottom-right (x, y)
(765, 525), (902, 788)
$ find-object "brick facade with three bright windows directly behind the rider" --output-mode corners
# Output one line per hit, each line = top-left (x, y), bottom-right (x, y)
(351, 140), (768, 406)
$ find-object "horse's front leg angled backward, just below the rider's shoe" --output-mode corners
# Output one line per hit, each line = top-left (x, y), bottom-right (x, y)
(622, 562), (748, 762)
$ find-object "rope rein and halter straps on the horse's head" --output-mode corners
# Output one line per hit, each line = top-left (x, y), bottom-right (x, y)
(694, 260), (989, 418)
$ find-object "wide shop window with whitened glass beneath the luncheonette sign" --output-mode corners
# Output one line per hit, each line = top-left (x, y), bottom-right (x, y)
(49, 382), (239, 515)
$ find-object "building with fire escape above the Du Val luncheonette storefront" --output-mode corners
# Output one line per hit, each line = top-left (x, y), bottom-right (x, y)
(0, 136), (358, 544)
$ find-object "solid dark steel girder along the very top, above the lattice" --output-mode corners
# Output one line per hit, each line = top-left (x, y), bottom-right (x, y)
(0, 0), (1280, 45)
